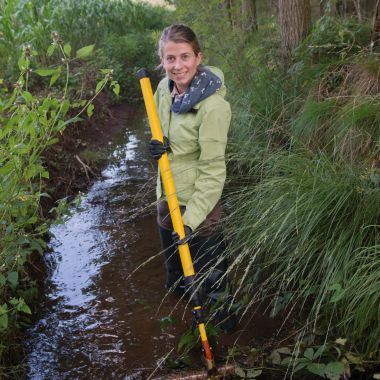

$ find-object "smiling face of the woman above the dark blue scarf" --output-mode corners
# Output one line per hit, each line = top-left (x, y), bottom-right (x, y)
(161, 41), (202, 93)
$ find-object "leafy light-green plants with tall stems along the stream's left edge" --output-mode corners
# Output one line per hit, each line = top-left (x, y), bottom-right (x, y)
(0, 33), (118, 374)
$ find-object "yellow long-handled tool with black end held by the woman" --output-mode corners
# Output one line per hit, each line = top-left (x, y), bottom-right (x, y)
(137, 69), (233, 379)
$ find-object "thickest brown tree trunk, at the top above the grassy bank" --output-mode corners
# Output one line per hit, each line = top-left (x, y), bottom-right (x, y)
(279, 0), (311, 66)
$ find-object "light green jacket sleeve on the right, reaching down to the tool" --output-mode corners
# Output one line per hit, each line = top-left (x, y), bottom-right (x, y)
(183, 100), (231, 231)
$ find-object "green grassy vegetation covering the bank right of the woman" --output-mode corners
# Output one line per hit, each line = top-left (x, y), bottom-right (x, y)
(176, 1), (380, 378)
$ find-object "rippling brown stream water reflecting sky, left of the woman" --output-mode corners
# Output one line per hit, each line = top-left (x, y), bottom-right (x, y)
(26, 111), (180, 379)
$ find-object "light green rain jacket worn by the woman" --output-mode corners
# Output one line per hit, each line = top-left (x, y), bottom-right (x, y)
(154, 66), (231, 231)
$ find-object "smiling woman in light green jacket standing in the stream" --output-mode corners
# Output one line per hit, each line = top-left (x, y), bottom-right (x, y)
(149, 25), (231, 332)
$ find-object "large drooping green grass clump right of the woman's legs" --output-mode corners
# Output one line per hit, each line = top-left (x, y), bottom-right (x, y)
(224, 152), (380, 355)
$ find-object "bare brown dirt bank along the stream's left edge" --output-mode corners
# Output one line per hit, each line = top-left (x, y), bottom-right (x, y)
(42, 96), (136, 211)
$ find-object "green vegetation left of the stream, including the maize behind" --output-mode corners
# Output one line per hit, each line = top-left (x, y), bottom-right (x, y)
(0, 0), (165, 378)
